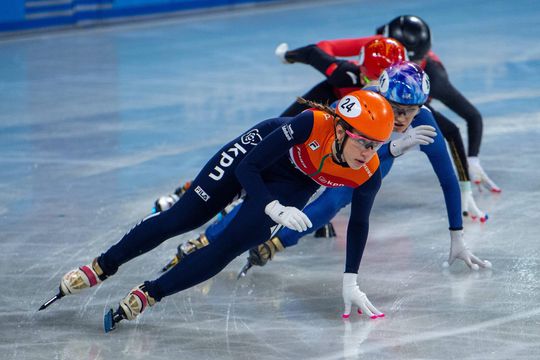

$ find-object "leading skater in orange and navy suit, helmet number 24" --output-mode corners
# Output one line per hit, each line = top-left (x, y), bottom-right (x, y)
(42, 90), (394, 331)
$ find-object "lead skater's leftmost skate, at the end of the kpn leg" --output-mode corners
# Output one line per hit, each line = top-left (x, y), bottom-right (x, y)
(39, 258), (107, 310)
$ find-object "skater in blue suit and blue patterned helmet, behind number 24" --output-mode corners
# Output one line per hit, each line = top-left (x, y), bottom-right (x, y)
(164, 61), (491, 274)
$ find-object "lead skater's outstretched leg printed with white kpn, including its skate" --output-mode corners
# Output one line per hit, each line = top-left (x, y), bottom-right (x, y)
(40, 120), (276, 309)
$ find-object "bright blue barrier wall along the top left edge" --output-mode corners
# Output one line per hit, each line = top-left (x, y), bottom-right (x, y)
(0, 0), (278, 35)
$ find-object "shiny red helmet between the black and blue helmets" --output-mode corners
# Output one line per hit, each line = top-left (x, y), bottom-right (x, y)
(358, 38), (408, 80)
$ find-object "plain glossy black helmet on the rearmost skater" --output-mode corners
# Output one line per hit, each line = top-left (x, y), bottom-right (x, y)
(377, 15), (431, 60)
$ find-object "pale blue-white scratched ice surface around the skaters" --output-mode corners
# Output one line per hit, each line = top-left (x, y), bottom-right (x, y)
(0, 0), (540, 360)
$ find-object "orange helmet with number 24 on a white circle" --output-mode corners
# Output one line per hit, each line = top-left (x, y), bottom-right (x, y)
(336, 90), (394, 141)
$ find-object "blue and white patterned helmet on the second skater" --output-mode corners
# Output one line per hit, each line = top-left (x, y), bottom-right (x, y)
(377, 61), (429, 105)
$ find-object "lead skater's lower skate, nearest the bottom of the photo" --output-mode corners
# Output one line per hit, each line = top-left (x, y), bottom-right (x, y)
(103, 284), (156, 333)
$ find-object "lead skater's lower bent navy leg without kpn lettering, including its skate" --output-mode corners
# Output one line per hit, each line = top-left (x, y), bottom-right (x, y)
(104, 179), (316, 332)
